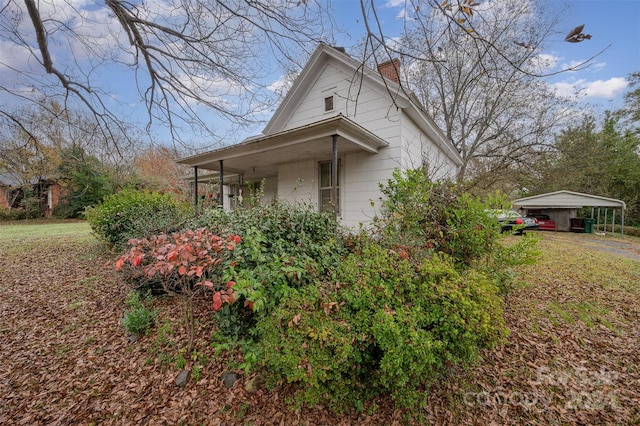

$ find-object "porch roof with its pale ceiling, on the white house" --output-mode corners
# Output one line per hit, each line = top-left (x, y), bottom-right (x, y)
(178, 115), (388, 179)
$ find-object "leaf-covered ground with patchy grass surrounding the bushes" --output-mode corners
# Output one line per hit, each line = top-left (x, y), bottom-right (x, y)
(0, 223), (640, 425)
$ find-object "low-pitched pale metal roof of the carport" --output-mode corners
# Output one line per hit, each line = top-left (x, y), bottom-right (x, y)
(513, 190), (627, 210)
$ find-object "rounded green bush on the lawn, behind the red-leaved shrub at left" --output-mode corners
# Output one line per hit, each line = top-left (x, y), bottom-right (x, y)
(84, 189), (190, 248)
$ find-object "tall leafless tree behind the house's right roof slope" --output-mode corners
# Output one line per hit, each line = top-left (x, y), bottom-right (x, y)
(352, 0), (601, 185)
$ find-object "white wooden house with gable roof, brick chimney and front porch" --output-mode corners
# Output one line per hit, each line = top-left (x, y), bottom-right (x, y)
(179, 44), (462, 226)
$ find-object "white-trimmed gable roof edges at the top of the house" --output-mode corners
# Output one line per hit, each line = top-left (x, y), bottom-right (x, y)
(263, 43), (462, 165)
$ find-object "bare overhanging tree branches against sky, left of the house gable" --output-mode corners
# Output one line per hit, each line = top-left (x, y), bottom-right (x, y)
(0, 0), (332, 150)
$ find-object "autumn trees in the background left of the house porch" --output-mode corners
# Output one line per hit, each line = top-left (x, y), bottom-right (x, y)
(0, 103), (184, 218)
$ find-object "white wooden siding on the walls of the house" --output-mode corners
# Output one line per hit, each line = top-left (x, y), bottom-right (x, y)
(268, 52), (457, 229)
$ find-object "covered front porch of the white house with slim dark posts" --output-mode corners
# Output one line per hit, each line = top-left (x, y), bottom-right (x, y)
(178, 115), (388, 215)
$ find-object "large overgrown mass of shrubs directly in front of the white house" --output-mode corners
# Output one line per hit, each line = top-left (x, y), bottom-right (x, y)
(111, 170), (535, 411)
